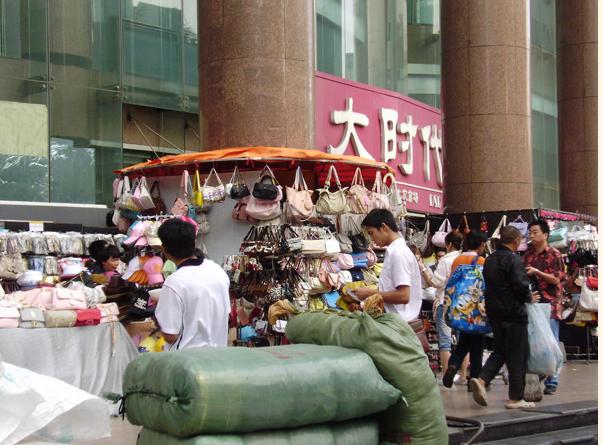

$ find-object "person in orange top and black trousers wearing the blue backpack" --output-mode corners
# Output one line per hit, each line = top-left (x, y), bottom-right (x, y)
(442, 230), (488, 389)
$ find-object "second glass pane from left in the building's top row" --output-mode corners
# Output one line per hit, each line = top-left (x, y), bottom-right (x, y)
(49, 0), (121, 89)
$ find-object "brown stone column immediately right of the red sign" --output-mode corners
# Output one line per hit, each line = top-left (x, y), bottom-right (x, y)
(441, 0), (533, 212)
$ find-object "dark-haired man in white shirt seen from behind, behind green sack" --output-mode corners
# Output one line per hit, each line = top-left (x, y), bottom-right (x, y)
(155, 219), (230, 350)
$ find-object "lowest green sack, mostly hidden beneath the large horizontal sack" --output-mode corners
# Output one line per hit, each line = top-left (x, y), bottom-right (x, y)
(138, 418), (379, 445)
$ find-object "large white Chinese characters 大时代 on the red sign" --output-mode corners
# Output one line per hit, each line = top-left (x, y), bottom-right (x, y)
(327, 97), (444, 187)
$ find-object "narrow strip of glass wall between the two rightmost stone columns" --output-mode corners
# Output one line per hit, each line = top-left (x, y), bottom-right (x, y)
(530, 0), (560, 209)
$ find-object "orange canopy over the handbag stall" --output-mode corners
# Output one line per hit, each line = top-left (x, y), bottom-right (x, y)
(114, 147), (395, 183)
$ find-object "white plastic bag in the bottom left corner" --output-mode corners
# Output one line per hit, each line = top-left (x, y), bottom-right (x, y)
(0, 362), (111, 445)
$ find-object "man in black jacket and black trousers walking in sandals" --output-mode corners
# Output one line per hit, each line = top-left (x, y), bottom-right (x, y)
(469, 226), (539, 409)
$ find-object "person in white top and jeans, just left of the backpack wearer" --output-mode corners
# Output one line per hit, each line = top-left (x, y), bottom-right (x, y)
(418, 232), (463, 378)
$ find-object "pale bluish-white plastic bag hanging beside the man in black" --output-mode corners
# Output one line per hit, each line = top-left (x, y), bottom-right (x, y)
(526, 303), (563, 377)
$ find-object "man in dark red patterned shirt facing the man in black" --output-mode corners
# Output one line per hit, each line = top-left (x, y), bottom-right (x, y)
(523, 219), (565, 394)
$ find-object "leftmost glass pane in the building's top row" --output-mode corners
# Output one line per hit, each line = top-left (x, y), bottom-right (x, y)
(0, 0), (48, 80)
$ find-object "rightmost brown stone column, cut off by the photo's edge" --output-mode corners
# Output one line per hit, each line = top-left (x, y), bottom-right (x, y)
(557, 0), (598, 215)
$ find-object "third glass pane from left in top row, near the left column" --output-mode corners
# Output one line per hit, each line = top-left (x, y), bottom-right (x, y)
(123, 0), (184, 110)
